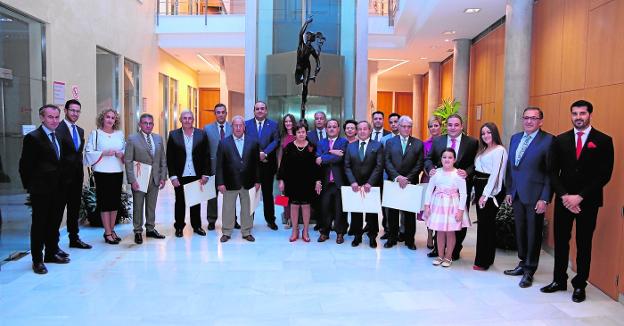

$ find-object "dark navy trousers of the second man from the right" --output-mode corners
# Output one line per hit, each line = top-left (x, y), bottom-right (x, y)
(512, 195), (544, 275)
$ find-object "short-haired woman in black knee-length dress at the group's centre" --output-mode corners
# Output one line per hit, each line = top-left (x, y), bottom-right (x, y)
(277, 120), (321, 242)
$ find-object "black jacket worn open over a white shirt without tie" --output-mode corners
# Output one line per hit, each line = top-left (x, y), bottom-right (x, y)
(167, 128), (210, 178)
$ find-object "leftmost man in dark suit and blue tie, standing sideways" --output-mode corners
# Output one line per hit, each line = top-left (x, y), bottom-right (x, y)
(19, 104), (69, 274)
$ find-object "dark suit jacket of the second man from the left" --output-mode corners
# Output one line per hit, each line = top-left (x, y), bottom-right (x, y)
(55, 121), (85, 183)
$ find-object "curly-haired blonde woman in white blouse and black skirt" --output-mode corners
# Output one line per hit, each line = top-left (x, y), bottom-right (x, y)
(85, 109), (126, 244)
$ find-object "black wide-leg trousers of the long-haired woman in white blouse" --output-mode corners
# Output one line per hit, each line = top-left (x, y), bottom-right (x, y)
(474, 172), (505, 268)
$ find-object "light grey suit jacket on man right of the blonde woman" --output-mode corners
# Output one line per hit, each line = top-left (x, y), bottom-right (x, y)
(124, 132), (167, 186)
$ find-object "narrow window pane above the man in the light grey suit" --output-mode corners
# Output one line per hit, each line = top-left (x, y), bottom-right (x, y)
(124, 59), (141, 137)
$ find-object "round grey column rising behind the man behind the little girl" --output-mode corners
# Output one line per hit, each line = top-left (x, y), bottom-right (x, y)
(453, 39), (472, 119)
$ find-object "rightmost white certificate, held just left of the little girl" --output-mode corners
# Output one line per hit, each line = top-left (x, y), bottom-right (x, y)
(381, 180), (427, 213)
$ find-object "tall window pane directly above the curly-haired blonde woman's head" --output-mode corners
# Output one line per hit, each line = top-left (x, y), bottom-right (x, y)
(95, 47), (119, 112)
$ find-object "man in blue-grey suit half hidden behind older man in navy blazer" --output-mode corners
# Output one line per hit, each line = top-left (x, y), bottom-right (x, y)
(204, 103), (235, 230)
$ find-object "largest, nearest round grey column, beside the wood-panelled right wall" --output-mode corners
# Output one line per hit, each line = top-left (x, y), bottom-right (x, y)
(502, 0), (533, 144)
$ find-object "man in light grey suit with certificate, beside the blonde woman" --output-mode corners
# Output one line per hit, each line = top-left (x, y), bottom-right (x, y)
(125, 113), (167, 244)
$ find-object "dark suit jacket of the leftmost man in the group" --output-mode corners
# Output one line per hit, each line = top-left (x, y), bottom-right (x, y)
(19, 126), (64, 195)
